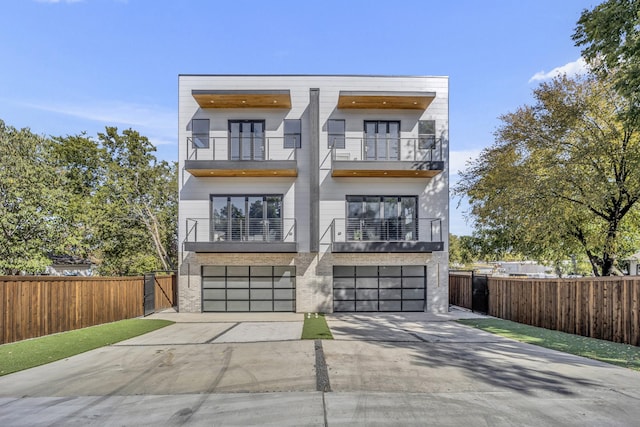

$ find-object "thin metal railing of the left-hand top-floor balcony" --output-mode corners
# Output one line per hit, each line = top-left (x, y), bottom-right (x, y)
(187, 135), (299, 161)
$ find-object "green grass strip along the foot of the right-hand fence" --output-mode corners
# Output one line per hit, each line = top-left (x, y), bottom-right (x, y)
(458, 319), (640, 371)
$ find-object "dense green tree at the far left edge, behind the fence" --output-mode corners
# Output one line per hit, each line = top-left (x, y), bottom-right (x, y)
(0, 120), (65, 274)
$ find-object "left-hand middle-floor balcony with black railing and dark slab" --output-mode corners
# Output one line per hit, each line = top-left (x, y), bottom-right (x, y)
(184, 218), (298, 253)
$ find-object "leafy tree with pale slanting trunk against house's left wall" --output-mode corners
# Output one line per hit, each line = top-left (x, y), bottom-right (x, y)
(96, 127), (177, 275)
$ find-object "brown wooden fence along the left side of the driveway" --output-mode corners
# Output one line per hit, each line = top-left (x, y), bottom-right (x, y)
(0, 275), (176, 344)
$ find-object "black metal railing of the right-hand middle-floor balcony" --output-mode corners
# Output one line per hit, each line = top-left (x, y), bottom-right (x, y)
(331, 218), (442, 243)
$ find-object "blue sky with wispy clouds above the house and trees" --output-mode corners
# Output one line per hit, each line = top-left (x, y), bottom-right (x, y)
(0, 0), (599, 234)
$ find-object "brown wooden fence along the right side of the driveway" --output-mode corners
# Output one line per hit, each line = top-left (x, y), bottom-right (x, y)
(449, 274), (640, 346)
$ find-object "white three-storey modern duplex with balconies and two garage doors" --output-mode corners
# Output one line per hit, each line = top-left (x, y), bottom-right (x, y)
(178, 75), (449, 312)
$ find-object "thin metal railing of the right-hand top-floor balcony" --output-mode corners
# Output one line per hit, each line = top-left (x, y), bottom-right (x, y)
(329, 136), (444, 162)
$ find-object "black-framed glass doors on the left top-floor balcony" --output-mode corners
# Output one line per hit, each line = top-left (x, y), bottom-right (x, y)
(229, 120), (265, 160)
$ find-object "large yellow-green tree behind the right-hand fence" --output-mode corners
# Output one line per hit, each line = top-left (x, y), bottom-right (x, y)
(455, 75), (640, 275)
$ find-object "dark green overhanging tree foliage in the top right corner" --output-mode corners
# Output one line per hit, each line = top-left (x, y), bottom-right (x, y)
(573, 0), (640, 120)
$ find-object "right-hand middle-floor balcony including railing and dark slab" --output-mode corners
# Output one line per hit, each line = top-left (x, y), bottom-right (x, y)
(331, 218), (444, 253)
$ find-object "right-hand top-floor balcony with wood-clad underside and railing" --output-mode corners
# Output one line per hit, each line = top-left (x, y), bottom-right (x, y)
(331, 136), (444, 178)
